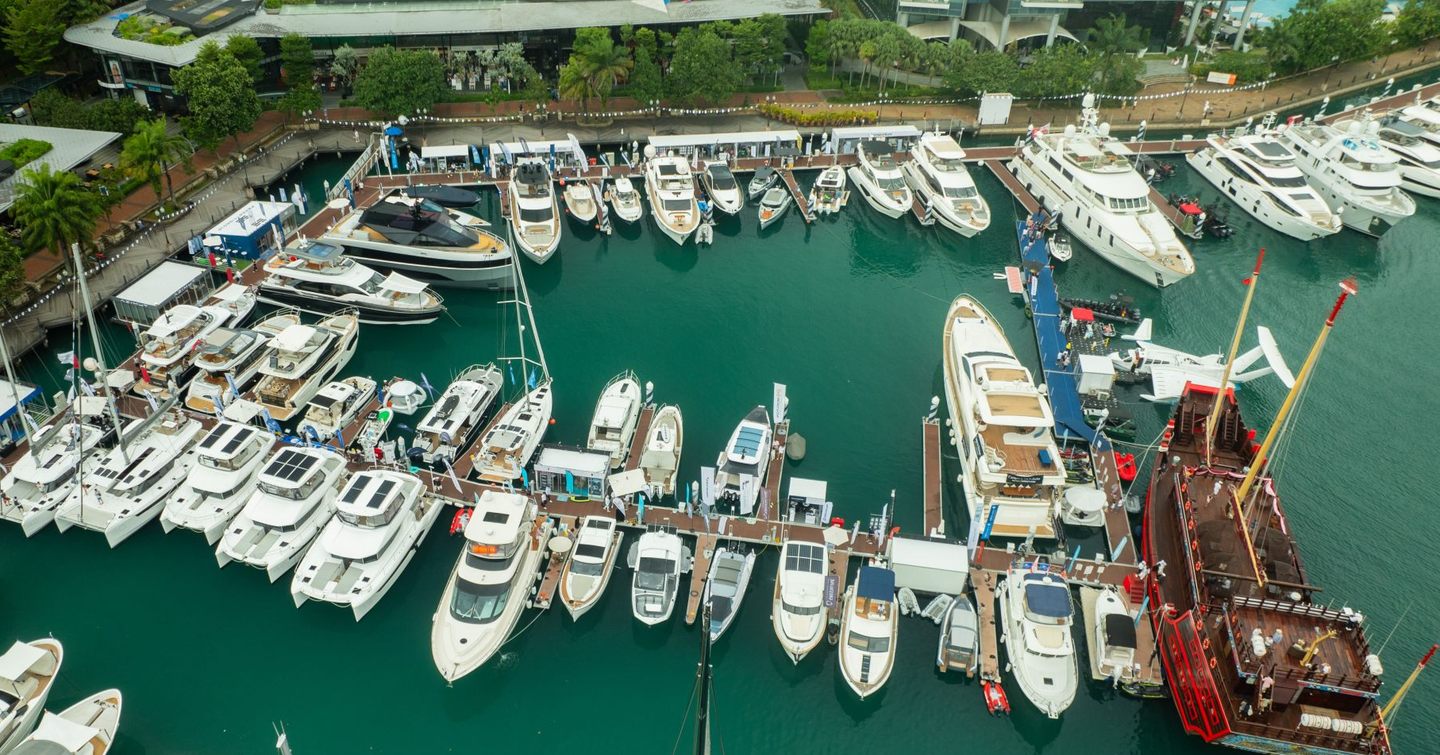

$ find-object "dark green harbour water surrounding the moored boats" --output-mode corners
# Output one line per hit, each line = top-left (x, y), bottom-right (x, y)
(0, 150), (1440, 755)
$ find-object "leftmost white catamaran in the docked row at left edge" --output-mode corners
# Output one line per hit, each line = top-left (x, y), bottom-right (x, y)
(0, 412), (115, 537)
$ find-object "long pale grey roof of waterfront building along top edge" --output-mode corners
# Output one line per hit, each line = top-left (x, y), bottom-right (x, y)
(65, 0), (828, 66)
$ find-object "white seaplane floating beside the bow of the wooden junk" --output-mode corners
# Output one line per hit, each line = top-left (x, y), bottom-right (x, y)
(1110, 317), (1295, 403)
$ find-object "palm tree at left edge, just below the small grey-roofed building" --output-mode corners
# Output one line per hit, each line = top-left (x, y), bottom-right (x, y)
(12, 164), (101, 258)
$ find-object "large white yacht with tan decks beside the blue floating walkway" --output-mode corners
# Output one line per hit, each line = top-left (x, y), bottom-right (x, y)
(942, 294), (1066, 537)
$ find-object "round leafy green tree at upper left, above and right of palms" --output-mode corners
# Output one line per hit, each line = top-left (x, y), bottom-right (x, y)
(173, 37), (261, 150)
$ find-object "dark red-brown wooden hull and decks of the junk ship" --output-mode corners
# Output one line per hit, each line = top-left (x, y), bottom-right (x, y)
(1143, 385), (1391, 755)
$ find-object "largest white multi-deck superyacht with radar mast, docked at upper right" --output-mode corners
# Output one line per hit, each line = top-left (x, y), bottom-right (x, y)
(1008, 95), (1195, 288)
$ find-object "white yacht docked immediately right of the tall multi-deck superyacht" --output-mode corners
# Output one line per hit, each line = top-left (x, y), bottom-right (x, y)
(1185, 128), (1342, 241)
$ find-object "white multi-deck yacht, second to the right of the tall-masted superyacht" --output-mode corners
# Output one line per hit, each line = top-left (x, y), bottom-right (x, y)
(1280, 121), (1416, 236)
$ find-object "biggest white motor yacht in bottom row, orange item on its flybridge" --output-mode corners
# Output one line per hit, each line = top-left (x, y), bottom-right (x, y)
(431, 490), (550, 682)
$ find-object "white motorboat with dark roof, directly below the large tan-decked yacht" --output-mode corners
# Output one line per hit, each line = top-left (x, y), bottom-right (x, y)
(998, 555), (1080, 719)
